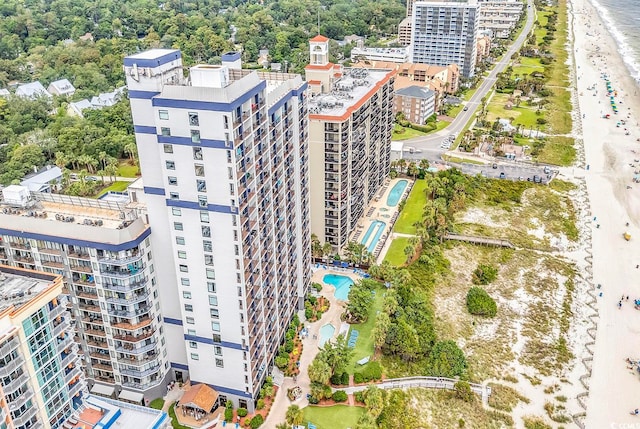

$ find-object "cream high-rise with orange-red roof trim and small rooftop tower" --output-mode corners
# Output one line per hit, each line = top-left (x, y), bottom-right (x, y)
(305, 35), (395, 250)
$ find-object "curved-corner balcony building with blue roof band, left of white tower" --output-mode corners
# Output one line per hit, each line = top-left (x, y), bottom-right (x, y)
(0, 185), (172, 400)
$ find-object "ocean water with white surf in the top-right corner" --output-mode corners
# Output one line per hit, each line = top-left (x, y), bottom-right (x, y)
(590, 0), (640, 83)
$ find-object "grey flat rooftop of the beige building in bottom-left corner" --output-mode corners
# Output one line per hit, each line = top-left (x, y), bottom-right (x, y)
(0, 266), (57, 312)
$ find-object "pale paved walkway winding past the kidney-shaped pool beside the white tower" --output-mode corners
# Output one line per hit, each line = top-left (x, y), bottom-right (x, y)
(263, 268), (361, 428)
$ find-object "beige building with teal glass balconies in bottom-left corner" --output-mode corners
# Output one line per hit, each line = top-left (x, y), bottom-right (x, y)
(0, 265), (86, 429)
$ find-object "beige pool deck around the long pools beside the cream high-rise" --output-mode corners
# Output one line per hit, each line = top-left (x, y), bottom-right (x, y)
(349, 177), (413, 263)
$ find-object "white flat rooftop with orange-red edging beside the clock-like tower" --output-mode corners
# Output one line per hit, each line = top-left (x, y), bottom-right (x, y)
(309, 68), (391, 116)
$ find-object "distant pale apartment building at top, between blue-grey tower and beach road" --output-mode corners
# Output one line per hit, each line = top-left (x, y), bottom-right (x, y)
(478, 0), (524, 39)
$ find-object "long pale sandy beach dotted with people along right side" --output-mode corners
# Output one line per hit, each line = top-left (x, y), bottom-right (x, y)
(570, 0), (640, 428)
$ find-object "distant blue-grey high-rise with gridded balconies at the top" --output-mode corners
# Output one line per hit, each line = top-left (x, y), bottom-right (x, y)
(409, 0), (478, 78)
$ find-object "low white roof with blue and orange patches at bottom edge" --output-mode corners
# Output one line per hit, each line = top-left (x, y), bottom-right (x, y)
(72, 395), (168, 429)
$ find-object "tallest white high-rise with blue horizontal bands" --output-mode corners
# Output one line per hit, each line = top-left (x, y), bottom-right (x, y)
(124, 49), (310, 409)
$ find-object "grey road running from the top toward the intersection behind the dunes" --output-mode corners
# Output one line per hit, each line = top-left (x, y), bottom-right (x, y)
(403, 0), (540, 172)
